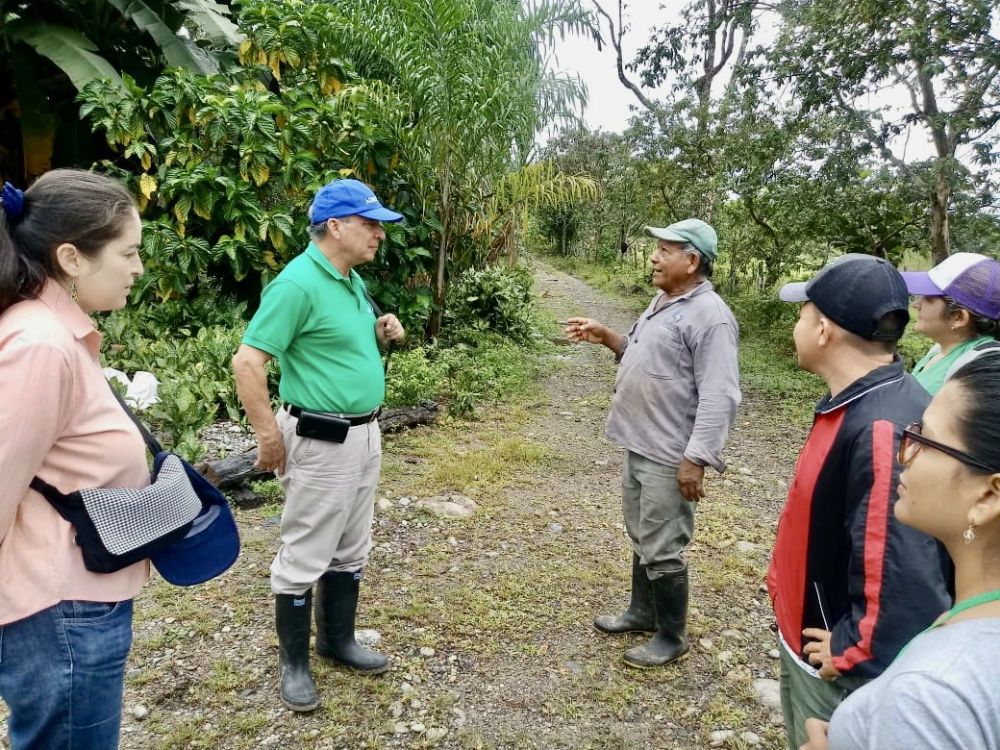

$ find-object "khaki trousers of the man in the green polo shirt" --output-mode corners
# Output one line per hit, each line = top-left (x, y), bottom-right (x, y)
(271, 409), (382, 595)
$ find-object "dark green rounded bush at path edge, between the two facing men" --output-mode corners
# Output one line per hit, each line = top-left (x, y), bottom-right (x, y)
(446, 266), (536, 344)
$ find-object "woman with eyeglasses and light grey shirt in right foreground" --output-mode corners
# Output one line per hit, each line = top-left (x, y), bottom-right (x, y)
(803, 351), (1000, 750)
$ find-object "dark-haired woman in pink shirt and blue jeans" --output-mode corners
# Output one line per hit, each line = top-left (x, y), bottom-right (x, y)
(0, 170), (149, 750)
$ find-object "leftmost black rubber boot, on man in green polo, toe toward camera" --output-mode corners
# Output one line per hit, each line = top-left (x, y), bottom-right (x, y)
(274, 591), (319, 711)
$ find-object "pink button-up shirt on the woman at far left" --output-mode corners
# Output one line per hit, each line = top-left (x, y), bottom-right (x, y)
(0, 280), (149, 625)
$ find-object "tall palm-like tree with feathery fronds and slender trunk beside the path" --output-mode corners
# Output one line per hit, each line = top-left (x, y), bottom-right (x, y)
(324, 0), (589, 337)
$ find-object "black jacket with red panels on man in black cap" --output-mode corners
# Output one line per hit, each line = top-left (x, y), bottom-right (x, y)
(767, 357), (951, 679)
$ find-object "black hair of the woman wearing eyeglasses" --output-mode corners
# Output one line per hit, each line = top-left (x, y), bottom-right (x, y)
(948, 350), (1000, 473)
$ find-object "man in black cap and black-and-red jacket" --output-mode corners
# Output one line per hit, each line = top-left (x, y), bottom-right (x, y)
(767, 254), (950, 748)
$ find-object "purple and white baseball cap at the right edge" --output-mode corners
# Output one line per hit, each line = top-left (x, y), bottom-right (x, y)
(902, 253), (1000, 320)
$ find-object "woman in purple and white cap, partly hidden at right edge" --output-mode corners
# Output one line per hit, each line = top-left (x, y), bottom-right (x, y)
(903, 253), (1000, 395)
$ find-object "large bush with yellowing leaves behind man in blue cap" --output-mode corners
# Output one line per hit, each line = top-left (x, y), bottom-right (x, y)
(79, 39), (440, 330)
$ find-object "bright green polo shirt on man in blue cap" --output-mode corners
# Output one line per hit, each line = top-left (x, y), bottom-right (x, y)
(243, 243), (385, 414)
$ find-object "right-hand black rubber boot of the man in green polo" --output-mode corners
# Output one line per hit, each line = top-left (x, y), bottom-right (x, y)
(315, 571), (389, 674)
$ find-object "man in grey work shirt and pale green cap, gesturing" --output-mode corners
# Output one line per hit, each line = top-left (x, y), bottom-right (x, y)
(566, 219), (740, 667)
